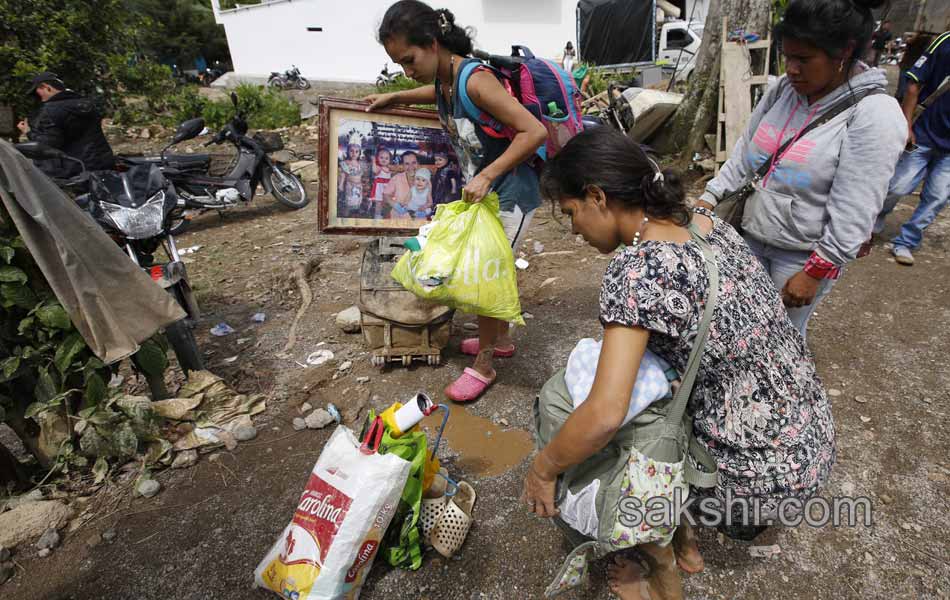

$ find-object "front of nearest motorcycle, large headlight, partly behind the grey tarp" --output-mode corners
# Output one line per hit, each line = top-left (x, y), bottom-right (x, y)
(16, 142), (204, 385)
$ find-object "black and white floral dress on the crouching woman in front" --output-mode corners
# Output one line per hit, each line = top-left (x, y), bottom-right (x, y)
(600, 212), (835, 518)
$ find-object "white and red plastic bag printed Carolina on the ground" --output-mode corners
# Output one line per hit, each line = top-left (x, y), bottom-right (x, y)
(254, 421), (410, 600)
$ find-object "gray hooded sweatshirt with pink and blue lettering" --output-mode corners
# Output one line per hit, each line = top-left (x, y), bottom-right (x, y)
(700, 63), (907, 266)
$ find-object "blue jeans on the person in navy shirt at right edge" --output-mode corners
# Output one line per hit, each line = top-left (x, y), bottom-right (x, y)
(874, 146), (950, 250)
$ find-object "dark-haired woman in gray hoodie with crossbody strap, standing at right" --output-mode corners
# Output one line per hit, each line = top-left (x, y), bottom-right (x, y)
(700, 0), (907, 337)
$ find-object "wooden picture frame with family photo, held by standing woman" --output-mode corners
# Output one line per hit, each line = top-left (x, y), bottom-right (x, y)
(317, 97), (464, 235)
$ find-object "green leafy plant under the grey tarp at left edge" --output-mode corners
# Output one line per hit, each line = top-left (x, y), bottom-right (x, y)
(0, 208), (170, 477)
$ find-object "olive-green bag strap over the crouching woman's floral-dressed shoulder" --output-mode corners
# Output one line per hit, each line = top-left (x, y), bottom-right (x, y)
(666, 224), (719, 487)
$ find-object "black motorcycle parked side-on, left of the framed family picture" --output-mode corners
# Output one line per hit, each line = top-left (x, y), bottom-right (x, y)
(118, 92), (310, 235)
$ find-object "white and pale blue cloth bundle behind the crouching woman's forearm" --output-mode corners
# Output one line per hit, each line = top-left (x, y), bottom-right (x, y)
(564, 338), (670, 425)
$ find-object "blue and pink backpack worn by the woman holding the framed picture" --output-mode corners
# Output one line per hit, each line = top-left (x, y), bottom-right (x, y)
(458, 46), (584, 160)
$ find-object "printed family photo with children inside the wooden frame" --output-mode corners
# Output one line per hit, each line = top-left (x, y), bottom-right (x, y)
(331, 118), (464, 227)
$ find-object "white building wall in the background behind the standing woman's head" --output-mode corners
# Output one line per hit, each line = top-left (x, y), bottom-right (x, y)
(212, 0), (577, 82)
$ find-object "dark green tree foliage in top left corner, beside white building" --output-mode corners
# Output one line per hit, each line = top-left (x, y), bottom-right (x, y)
(0, 0), (230, 116)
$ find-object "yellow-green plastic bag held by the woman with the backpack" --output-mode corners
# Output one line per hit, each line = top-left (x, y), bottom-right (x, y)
(392, 193), (524, 325)
